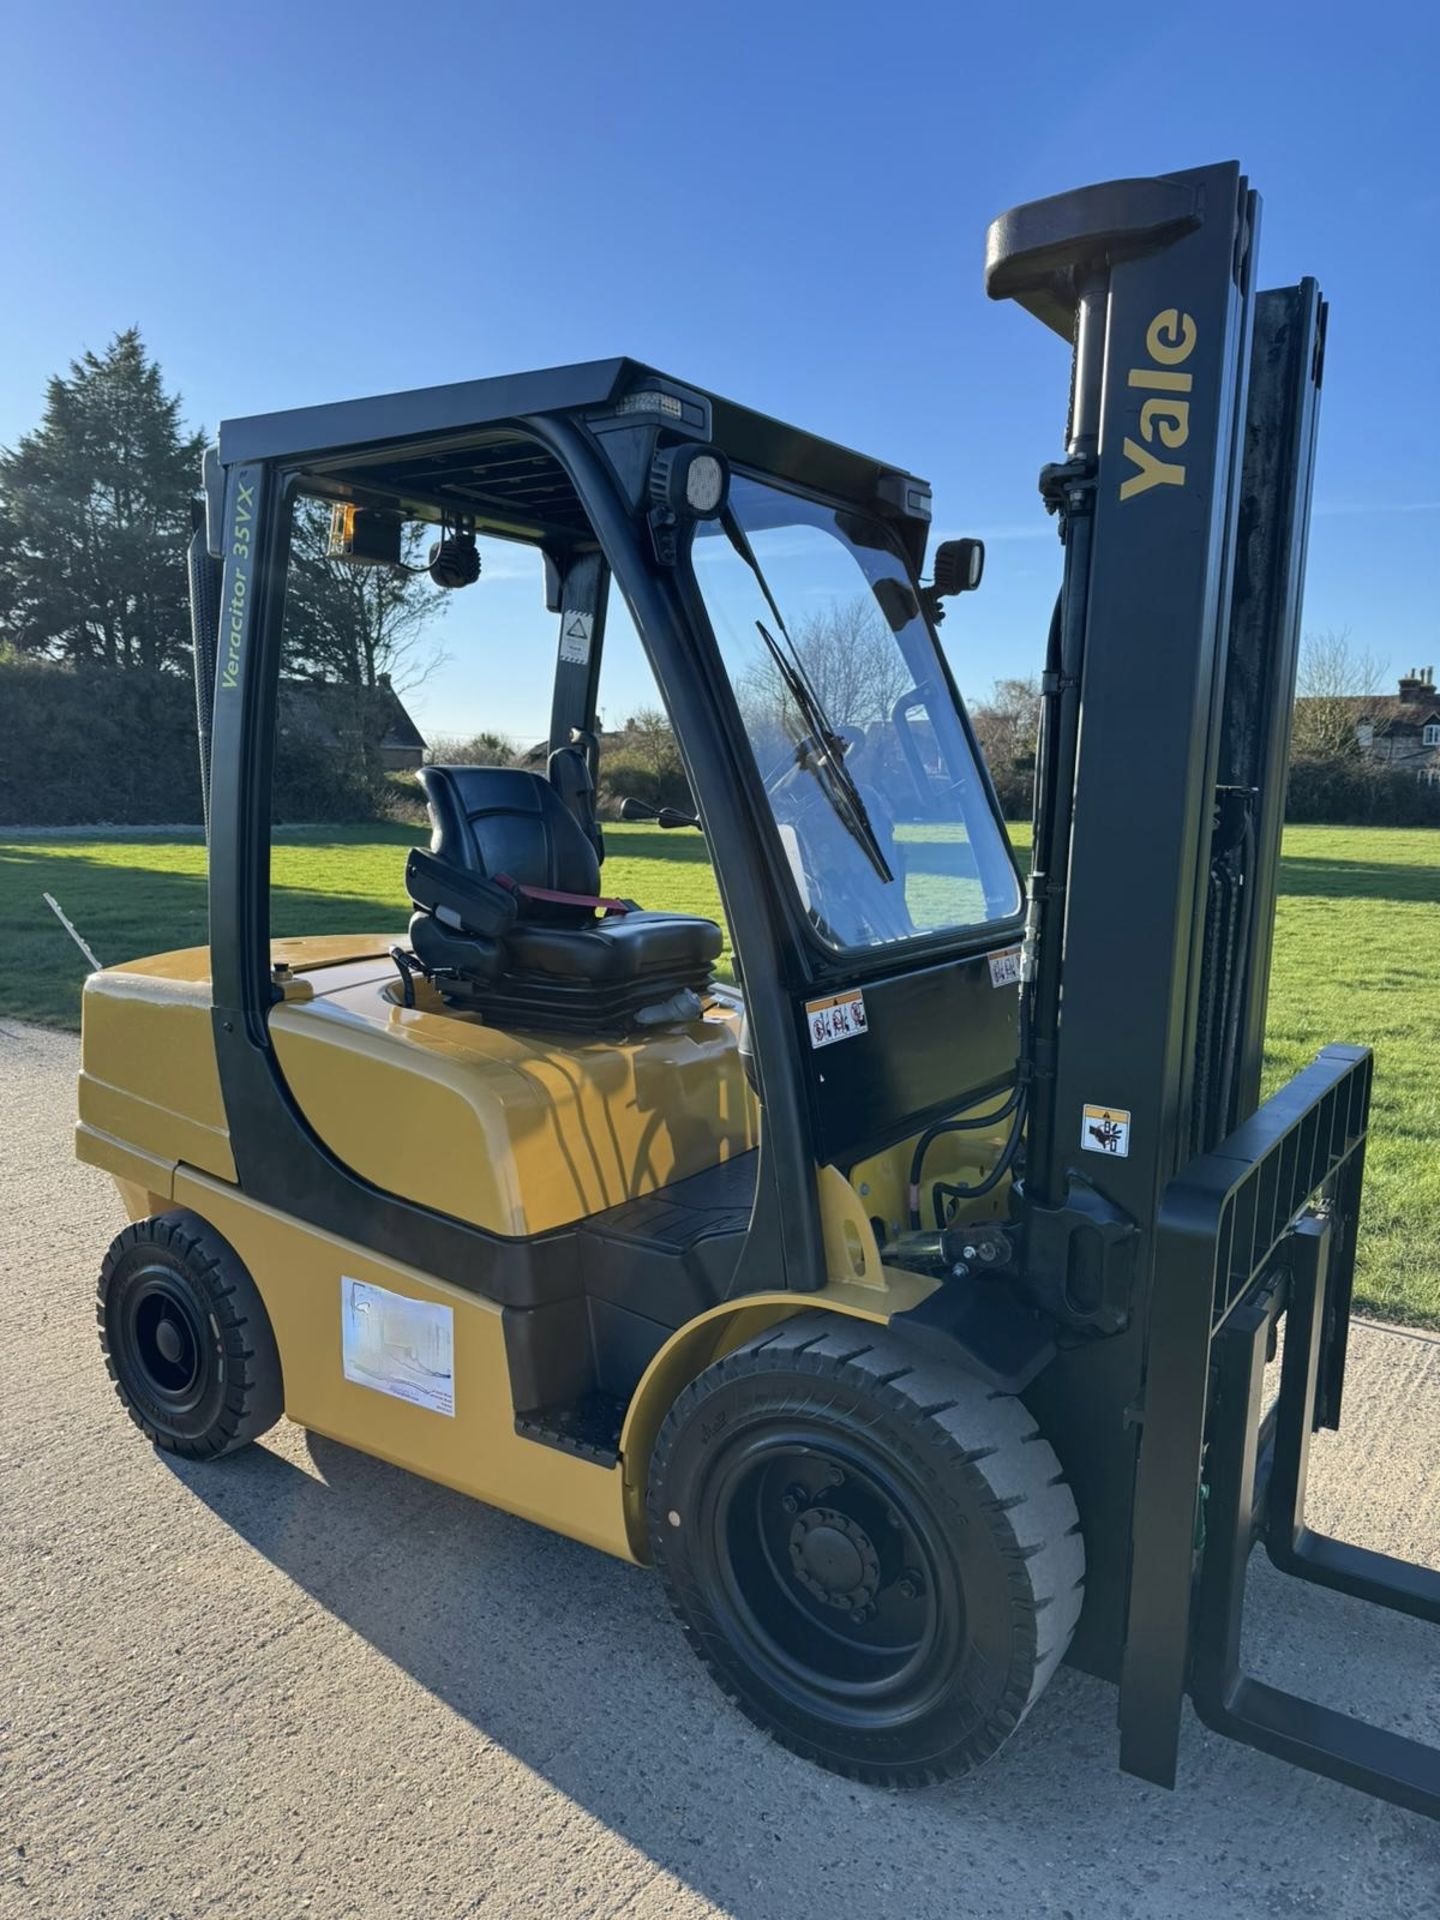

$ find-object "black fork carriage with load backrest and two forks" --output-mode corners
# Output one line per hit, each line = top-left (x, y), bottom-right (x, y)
(1121, 1046), (1440, 1818)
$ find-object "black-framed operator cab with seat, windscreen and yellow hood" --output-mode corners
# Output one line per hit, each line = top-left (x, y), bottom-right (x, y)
(192, 361), (1021, 1427)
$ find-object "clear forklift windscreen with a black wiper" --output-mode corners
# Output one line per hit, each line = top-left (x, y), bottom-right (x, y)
(691, 474), (1020, 947)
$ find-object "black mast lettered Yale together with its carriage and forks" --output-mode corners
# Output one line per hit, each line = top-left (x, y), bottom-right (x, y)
(987, 163), (1440, 1814)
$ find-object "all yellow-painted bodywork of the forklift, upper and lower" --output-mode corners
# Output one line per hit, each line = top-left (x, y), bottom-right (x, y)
(77, 935), (1006, 1561)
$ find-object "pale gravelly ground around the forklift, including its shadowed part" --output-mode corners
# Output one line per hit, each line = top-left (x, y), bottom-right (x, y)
(0, 1023), (1440, 1920)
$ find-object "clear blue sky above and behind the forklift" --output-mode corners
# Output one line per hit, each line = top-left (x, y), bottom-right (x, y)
(0, 0), (1440, 733)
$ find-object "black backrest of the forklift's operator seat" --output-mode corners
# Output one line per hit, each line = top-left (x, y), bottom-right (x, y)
(419, 766), (599, 902)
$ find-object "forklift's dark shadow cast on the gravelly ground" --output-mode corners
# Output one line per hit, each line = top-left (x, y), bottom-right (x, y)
(167, 1436), (1436, 1920)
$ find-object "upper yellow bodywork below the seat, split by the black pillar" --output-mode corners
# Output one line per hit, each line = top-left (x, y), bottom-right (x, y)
(77, 935), (758, 1235)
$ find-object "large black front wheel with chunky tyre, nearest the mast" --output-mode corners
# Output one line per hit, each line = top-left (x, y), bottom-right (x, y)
(649, 1313), (1085, 1786)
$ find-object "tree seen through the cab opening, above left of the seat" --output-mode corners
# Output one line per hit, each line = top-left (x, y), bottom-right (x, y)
(284, 497), (447, 693)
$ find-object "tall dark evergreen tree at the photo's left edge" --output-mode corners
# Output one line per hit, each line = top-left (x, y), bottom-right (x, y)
(0, 326), (204, 668)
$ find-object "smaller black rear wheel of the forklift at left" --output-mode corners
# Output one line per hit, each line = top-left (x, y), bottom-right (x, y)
(96, 1210), (284, 1459)
